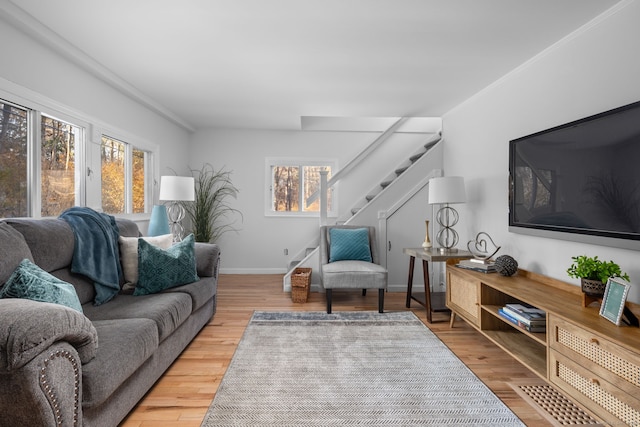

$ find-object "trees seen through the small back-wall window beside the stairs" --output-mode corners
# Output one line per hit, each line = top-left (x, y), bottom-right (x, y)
(271, 165), (331, 212)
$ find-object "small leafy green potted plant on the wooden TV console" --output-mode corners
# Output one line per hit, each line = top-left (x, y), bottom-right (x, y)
(567, 255), (629, 297)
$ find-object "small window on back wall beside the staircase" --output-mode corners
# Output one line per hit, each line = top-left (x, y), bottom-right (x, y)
(266, 159), (336, 215)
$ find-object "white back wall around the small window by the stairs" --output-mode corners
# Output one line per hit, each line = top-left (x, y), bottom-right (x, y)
(190, 129), (428, 273)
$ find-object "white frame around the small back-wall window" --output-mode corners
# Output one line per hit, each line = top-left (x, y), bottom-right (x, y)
(264, 157), (338, 217)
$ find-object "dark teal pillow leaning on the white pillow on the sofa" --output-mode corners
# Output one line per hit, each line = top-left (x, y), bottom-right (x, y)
(133, 234), (199, 295)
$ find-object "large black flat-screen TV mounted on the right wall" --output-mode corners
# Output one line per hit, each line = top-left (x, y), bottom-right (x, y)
(509, 102), (640, 250)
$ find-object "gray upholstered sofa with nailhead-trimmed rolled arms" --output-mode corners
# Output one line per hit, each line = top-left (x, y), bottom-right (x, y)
(0, 219), (220, 427)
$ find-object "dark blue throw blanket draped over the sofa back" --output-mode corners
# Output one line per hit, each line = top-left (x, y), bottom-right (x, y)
(60, 206), (122, 305)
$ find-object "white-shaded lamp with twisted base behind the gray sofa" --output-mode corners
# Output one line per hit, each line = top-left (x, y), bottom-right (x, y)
(160, 175), (196, 242)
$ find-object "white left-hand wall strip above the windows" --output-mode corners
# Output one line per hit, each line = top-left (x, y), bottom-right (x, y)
(0, 17), (189, 190)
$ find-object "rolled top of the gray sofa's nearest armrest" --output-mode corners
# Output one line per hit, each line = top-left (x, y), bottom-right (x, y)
(0, 298), (98, 371)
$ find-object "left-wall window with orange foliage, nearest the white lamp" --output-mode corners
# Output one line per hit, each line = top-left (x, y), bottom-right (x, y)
(100, 135), (149, 214)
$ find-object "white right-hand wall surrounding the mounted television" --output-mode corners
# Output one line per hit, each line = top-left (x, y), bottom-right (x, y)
(443, 1), (640, 302)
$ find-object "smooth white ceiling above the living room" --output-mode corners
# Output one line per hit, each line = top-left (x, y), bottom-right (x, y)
(3, 0), (618, 130)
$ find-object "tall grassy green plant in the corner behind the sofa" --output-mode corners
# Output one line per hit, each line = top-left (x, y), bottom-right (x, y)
(182, 163), (242, 243)
